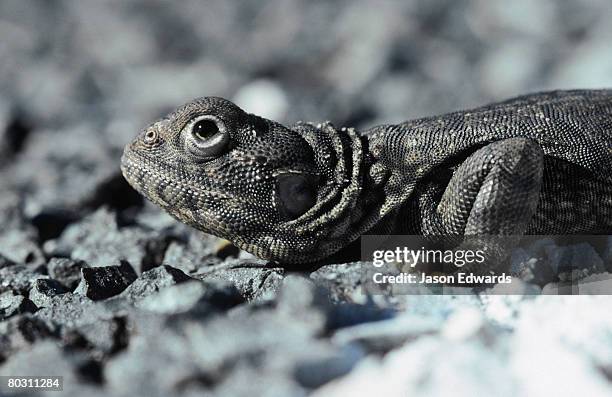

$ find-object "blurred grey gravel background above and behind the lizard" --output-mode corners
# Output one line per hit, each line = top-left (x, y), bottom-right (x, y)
(0, 0), (612, 223)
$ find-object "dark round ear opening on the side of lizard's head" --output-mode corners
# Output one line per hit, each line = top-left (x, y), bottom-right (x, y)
(276, 173), (317, 220)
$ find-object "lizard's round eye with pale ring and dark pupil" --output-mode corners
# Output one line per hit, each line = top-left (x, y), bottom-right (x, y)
(185, 116), (230, 160)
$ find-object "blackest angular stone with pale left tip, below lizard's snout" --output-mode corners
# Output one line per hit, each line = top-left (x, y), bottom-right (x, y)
(74, 261), (138, 300)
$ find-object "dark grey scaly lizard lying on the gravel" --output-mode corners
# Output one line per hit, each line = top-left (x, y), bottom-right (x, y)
(121, 89), (612, 270)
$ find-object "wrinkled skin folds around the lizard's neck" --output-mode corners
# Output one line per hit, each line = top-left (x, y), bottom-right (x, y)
(276, 123), (390, 257)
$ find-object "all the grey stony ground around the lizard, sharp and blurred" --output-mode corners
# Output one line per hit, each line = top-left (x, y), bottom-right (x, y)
(0, 0), (612, 396)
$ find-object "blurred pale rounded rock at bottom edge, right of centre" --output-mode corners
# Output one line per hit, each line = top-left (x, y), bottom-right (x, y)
(313, 336), (516, 397)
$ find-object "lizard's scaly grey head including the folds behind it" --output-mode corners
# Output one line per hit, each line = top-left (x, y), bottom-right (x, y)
(121, 97), (362, 263)
